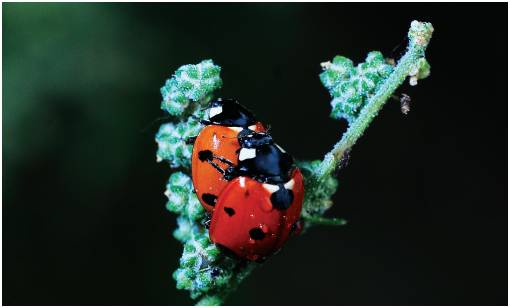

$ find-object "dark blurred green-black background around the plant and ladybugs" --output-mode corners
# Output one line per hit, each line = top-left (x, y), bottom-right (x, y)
(2, 4), (508, 305)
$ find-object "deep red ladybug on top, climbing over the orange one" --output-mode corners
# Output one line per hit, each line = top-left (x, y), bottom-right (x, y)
(209, 132), (304, 262)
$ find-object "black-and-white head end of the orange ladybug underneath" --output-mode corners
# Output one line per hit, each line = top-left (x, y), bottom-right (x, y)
(208, 98), (257, 128)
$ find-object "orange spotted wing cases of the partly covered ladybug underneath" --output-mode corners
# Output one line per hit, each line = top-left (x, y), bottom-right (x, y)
(191, 122), (265, 213)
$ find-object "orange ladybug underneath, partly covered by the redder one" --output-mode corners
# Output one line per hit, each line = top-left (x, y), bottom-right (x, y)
(189, 99), (266, 213)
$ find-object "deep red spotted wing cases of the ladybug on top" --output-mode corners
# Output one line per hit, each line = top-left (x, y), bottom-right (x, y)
(209, 168), (304, 261)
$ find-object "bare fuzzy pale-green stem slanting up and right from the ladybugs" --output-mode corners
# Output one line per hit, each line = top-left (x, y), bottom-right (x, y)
(314, 21), (433, 183)
